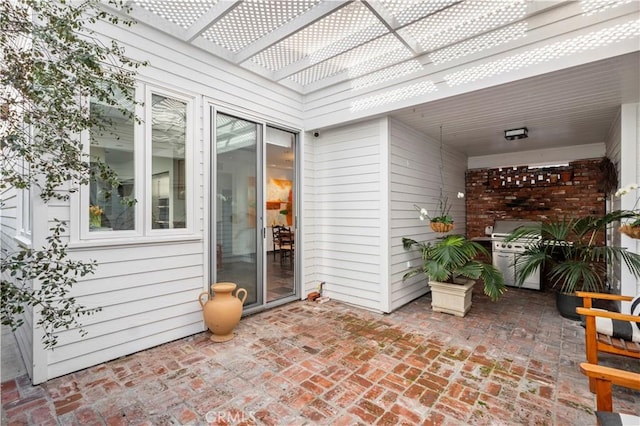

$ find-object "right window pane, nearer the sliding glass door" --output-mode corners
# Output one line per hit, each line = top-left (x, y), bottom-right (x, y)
(151, 94), (187, 229)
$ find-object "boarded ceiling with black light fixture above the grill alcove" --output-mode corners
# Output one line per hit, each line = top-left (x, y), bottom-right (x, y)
(390, 52), (640, 158)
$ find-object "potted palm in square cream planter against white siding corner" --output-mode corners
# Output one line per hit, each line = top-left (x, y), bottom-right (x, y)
(402, 235), (505, 317)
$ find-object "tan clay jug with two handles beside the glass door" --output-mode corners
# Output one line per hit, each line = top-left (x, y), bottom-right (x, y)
(198, 283), (247, 342)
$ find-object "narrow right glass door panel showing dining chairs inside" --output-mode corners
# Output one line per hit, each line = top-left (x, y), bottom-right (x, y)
(265, 126), (296, 302)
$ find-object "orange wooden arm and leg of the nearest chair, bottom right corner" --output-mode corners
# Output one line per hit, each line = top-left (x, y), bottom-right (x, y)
(580, 362), (640, 425)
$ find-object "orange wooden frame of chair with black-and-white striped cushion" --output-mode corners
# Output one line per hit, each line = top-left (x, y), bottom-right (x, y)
(576, 291), (640, 392)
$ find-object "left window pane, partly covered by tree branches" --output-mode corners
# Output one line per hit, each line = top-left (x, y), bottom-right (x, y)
(88, 88), (135, 232)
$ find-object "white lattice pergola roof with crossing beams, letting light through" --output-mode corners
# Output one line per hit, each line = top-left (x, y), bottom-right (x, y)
(129, 0), (632, 93)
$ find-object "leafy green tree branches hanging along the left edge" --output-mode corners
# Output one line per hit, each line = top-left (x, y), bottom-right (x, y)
(0, 0), (143, 347)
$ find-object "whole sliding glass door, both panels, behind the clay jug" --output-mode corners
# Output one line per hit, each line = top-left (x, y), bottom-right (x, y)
(211, 112), (298, 311)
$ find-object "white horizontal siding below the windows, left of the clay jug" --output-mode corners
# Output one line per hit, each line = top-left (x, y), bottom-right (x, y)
(47, 241), (206, 378)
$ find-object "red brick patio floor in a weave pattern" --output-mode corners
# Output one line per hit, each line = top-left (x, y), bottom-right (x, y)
(2, 286), (640, 425)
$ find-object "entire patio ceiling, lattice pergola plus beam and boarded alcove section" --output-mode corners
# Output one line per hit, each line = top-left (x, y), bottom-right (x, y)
(128, 0), (640, 156)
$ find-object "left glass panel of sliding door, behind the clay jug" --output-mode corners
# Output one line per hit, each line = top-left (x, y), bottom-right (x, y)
(213, 113), (263, 308)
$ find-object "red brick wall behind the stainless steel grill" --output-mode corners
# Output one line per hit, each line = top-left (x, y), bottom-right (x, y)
(465, 158), (605, 238)
